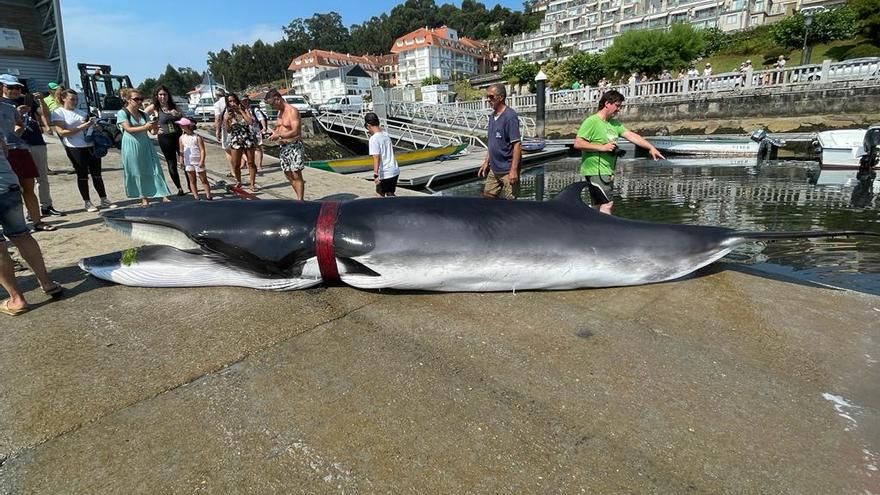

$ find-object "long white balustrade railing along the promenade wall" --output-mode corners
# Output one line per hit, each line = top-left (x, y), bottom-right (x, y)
(442, 57), (880, 111)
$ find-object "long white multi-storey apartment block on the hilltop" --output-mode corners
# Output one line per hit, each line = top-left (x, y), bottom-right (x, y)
(505, 0), (780, 62)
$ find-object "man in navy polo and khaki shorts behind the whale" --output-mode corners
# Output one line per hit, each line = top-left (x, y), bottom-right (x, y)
(477, 83), (522, 199)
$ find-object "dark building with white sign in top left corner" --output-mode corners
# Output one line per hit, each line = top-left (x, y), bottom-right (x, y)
(0, 0), (67, 91)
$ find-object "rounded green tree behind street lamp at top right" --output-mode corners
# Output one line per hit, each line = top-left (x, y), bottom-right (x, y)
(771, 6), (860, 48)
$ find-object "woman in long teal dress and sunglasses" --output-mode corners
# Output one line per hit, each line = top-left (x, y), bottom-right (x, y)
(116, 88), (171, 207)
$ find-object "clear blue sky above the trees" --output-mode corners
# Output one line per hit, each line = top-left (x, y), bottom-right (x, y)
(61, 0), (522, 85)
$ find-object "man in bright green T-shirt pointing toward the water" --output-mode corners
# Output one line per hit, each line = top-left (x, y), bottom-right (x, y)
(574, 89), (665, 215)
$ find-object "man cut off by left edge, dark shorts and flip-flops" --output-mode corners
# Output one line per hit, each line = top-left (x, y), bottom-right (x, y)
(0, 138), (62, 316)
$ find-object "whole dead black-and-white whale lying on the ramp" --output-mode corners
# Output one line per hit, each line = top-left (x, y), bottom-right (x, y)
(80, 182), (878, 292)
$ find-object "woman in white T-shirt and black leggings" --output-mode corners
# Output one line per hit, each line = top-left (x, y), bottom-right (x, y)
(51, 89), (116, 211)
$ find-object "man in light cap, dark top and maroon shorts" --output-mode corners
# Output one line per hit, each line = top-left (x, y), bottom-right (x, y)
(0, 74), (55, 232)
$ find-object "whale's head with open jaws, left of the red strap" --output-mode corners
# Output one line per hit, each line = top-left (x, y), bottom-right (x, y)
(80, 200), (321, 289)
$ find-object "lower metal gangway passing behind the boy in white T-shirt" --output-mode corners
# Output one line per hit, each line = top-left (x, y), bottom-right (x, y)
(315, 113), (487, 149)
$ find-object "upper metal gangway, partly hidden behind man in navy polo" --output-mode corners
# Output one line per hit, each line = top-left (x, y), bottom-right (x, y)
(387, 100), (535, 137)
